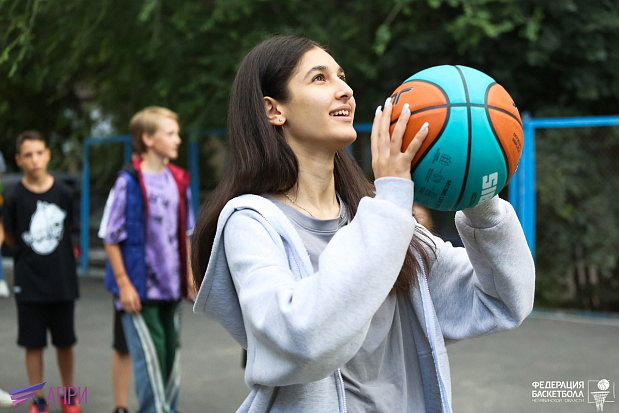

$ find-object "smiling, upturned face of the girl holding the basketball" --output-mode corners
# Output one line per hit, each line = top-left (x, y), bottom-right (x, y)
(277, 48), (357, 155)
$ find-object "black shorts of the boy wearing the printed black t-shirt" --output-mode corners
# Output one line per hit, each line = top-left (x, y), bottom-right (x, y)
(17, 301), (77, 349)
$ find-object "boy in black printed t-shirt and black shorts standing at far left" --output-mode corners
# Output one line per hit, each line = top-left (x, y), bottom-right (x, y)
(3, 131), (81, 413)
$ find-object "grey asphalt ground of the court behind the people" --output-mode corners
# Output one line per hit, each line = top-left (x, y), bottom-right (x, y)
(0, 259), (619, 413)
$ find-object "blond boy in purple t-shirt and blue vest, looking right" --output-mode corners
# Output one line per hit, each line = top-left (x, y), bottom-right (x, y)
(104, 106), (195, 413)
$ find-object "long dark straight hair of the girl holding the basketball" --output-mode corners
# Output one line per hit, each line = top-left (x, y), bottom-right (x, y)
(191, 36), (430, 292)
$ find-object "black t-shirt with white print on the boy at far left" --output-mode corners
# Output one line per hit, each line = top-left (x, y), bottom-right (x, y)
(3, 180), (79, 302)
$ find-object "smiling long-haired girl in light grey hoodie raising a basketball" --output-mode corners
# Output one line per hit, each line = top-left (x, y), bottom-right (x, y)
(192, 36), (534, 413)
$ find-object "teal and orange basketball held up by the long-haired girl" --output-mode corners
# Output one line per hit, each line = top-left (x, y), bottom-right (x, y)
(391, 65), (523, 211)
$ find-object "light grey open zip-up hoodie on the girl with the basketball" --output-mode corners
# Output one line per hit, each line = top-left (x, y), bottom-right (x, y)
(194, 178), (535, 413)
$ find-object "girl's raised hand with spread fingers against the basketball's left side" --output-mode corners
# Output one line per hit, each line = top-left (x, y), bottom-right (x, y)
(371, 98), (428, 179)
